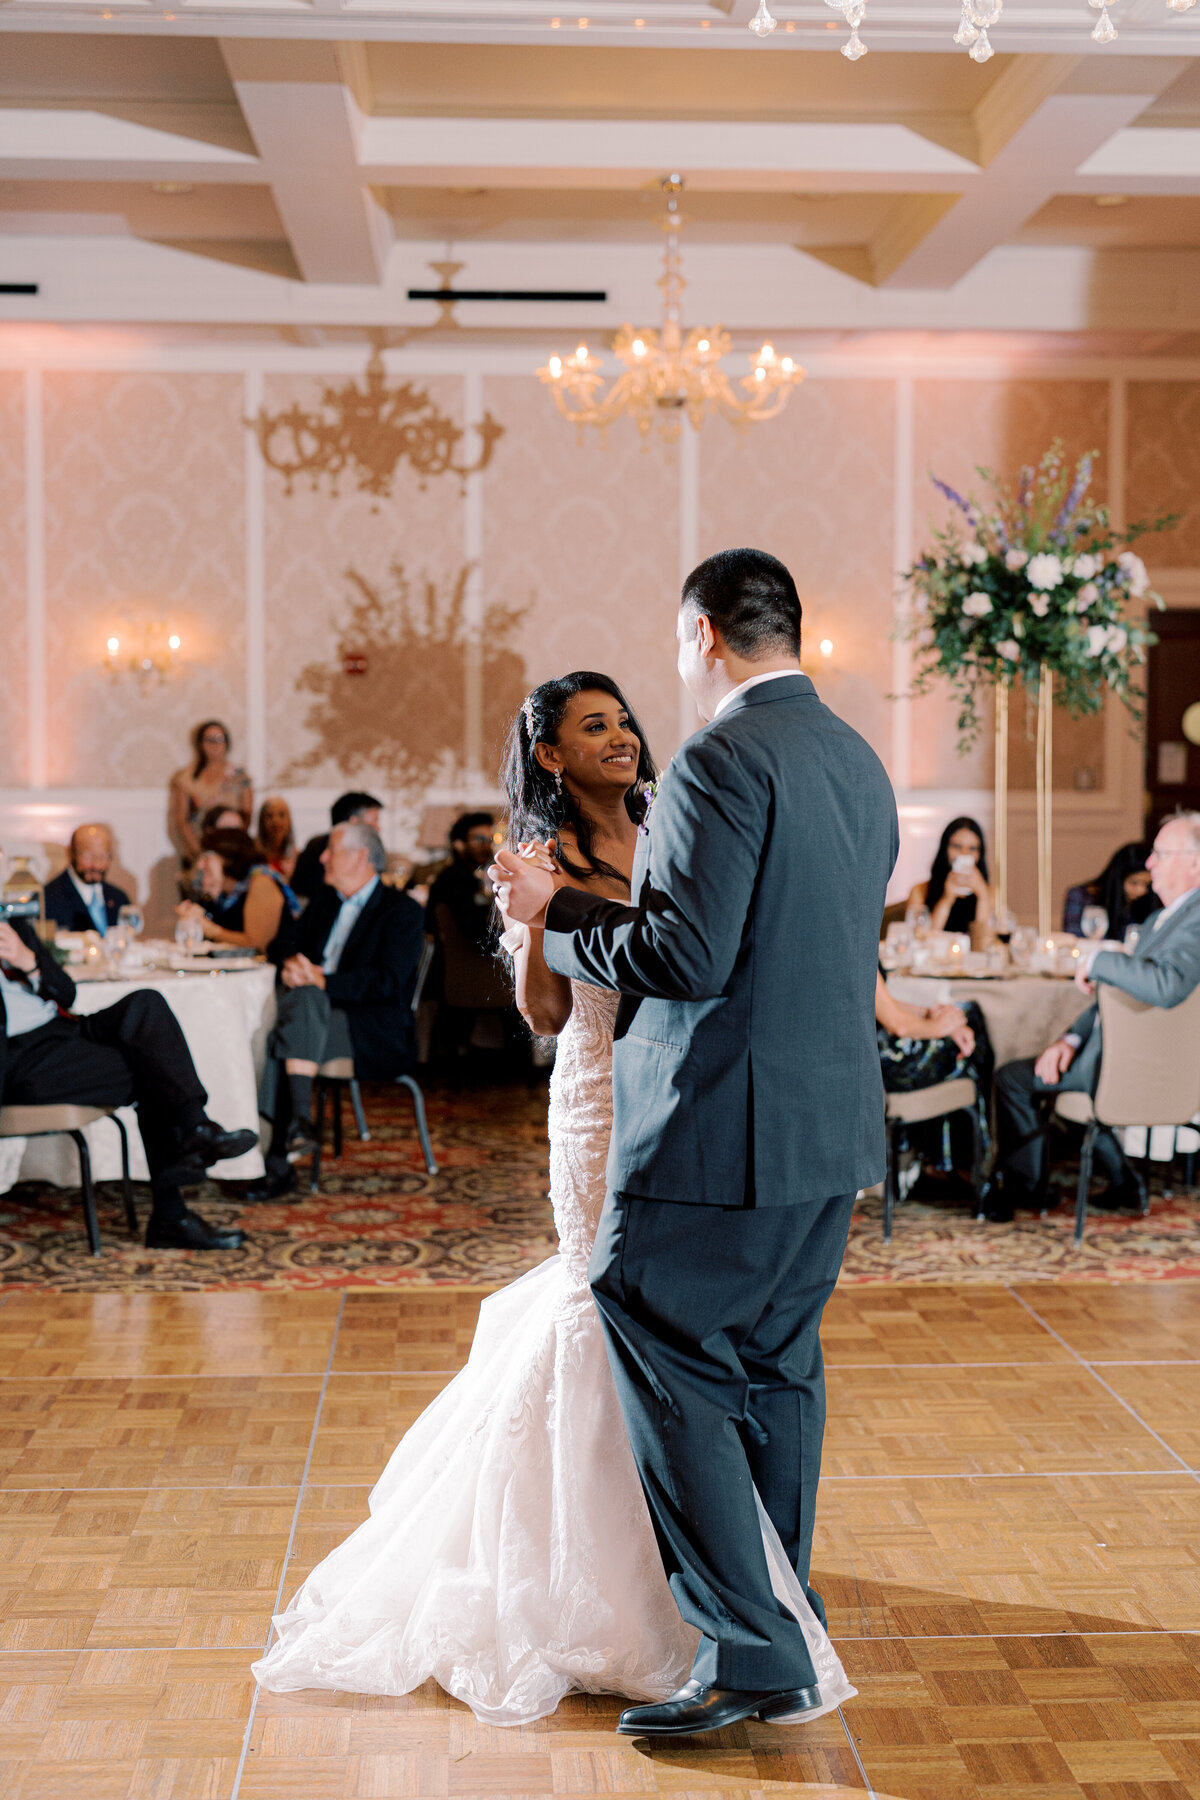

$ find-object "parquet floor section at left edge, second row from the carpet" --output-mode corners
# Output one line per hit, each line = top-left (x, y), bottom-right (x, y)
(0, 1375), (320, 1489)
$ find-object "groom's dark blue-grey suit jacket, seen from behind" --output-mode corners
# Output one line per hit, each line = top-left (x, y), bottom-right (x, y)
(545, 673), (898, 1206)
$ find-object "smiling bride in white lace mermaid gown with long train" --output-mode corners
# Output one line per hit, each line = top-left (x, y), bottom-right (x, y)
(254, 671), (855, 1724)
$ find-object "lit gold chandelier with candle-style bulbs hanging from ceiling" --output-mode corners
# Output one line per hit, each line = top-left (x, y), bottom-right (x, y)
(538, 175), (804, 439)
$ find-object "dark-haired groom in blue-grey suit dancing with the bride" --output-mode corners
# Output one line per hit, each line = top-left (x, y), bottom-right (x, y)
(491, 549), (898, 1737)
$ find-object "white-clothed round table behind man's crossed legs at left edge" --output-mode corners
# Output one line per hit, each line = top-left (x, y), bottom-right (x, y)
(0, 963), (275, 1193)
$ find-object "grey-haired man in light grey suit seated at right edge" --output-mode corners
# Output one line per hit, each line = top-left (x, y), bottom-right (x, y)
(990, 812), (1200, 1220)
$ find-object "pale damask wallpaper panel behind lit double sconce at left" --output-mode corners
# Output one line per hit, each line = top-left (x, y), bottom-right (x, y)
(45, 371), (246, 790)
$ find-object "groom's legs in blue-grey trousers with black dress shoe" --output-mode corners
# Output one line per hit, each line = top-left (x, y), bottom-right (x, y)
(590, 1193), (855, 1737)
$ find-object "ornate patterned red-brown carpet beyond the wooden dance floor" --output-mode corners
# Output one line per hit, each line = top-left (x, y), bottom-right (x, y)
(0, 1085), (1200, 1292)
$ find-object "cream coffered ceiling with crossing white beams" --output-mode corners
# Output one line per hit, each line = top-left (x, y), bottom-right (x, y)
(0, 0), (1200, 337)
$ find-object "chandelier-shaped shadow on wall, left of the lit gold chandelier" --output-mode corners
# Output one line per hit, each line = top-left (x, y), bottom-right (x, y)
(245, 346), (504, 511)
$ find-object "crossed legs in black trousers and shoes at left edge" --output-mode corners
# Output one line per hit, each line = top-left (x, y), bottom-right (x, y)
(4, 988), (257, 1249)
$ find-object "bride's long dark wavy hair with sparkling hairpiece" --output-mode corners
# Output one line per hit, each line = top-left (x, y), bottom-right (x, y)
(504, 670), (657, 880)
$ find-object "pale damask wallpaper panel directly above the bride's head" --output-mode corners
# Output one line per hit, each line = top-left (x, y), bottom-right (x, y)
(484, 376), (678, 777)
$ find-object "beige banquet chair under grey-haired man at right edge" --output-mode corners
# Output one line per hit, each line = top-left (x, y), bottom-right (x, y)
(1054, 983), (1200, 1244)
